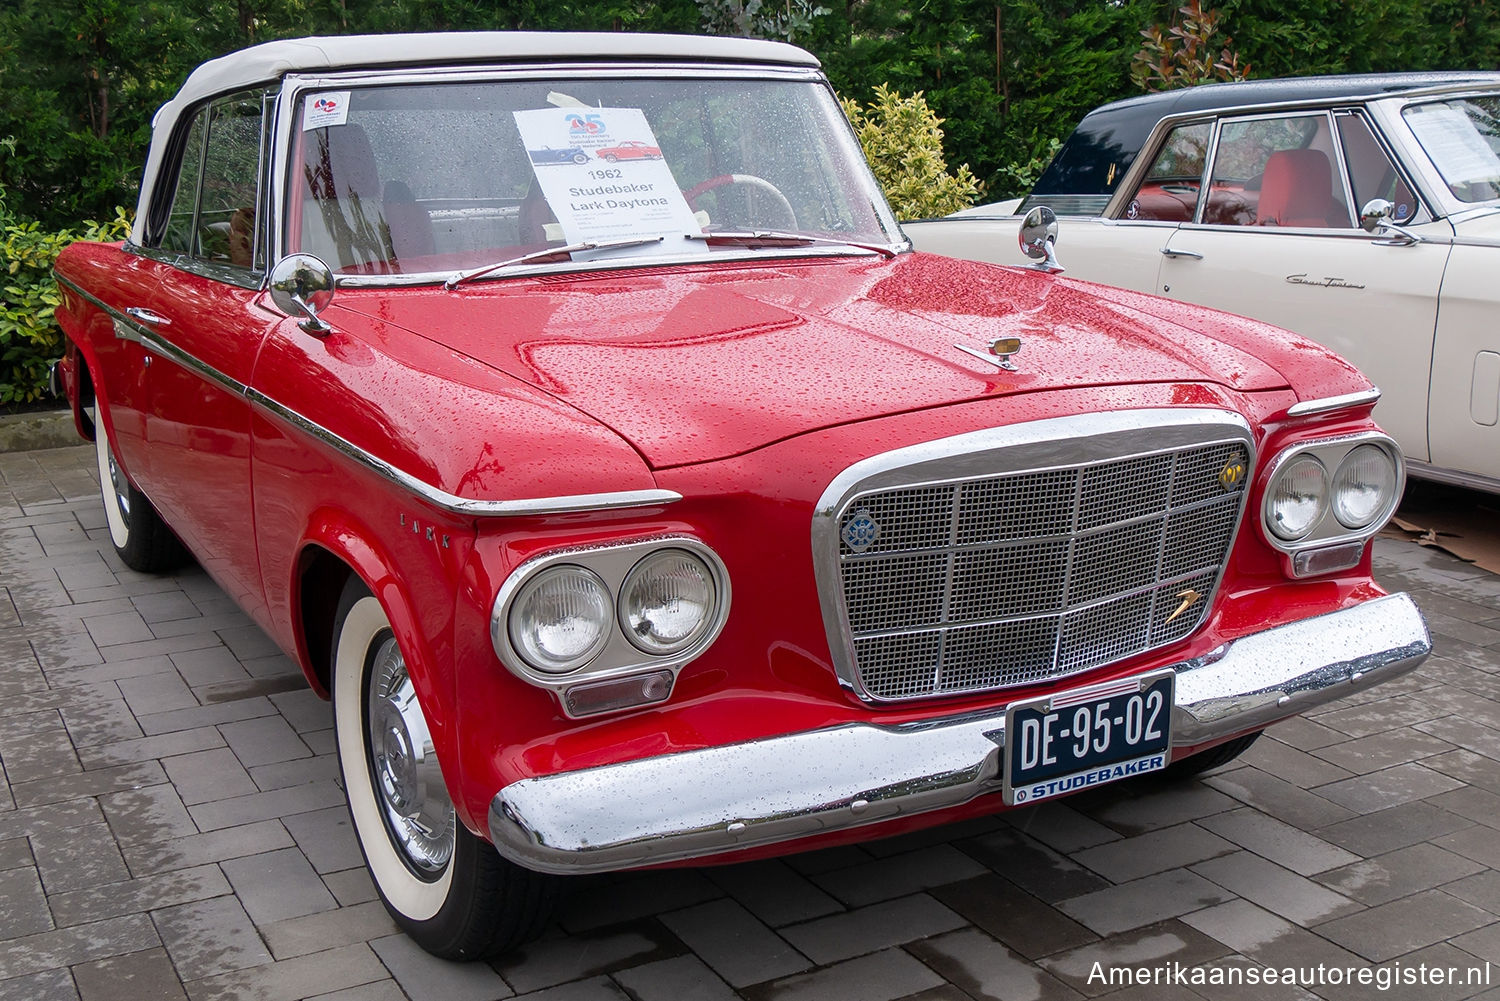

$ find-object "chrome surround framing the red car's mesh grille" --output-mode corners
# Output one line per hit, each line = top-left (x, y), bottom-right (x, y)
(812, 407), (1257, 704)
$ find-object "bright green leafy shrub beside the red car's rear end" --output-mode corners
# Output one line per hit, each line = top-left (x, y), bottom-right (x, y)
(0, 203), (131, 407)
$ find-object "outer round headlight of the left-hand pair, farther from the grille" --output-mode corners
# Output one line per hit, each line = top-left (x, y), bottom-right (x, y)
(509, 564), (614, 674)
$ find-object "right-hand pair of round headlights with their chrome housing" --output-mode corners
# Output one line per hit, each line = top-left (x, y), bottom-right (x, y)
(1262, 434), (1406, 576)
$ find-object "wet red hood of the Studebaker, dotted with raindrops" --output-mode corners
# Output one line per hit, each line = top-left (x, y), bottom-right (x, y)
(339, 254), (1287, 468)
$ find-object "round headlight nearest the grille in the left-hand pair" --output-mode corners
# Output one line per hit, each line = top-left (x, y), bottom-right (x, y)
(620, 549), (719, 656)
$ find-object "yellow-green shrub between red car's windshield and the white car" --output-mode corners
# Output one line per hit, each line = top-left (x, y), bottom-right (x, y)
(842, 84), (981, 219)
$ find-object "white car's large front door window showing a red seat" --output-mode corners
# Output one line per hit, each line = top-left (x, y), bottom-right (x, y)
(1203, 113), (1355, 230)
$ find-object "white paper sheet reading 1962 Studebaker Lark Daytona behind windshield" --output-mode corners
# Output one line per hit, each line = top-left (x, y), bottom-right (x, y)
(515, 108), (701, 254)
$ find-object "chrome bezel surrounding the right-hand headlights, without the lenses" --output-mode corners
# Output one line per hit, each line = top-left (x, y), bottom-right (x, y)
(1260, 431), (1406, 576)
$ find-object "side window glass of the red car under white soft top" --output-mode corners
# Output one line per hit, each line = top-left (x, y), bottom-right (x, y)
(159, 92), (264, 269)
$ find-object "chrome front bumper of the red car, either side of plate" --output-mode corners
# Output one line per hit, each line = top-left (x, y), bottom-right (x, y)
(489, 594), (1433, 873)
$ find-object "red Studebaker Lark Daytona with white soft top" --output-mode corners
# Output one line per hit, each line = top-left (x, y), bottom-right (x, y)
(57, 35), (1430, 957)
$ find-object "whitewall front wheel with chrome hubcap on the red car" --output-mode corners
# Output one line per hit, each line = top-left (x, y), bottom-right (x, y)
(333, 578), (555, 959)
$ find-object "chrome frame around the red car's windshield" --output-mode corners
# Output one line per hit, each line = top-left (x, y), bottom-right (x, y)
(270, 62), (912, 274)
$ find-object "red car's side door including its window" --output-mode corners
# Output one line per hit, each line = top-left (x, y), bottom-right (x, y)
(132, 92), (281, 617)
